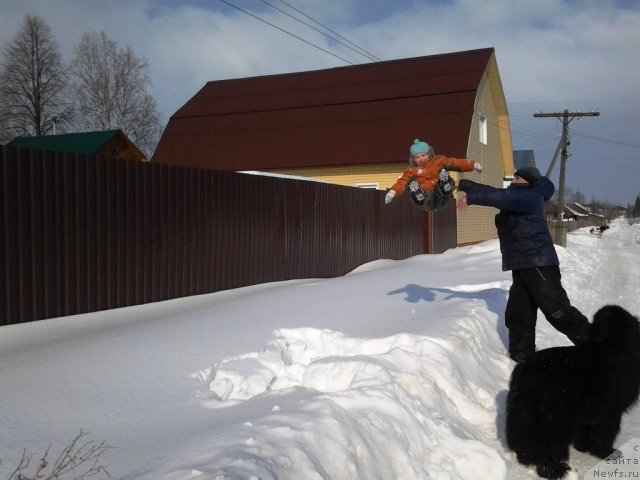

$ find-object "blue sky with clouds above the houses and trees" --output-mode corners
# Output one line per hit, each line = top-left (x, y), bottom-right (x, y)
(0, 0), (640, 205)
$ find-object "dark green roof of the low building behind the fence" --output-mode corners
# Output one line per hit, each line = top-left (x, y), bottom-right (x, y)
(9, 130), (120, 155)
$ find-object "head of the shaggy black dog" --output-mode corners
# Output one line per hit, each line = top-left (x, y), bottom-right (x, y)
(589, 305), (640, 354)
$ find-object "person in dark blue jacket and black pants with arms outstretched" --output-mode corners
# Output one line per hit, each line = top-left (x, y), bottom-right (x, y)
(458, 167), (589, 362)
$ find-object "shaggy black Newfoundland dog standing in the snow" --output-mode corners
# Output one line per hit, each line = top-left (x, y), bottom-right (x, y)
(506, 305), (640, 479)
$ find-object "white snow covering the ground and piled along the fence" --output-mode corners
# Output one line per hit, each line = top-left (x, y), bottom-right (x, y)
(0, 221), (640, 480)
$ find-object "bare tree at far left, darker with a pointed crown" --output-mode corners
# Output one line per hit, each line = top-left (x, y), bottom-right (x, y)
(0, 15), (73, 139)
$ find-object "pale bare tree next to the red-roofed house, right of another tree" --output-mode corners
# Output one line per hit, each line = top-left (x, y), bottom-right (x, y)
(72, 32), (161, 157)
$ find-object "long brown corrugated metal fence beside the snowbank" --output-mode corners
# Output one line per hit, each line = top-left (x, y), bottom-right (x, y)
(0, 147), (455, 325)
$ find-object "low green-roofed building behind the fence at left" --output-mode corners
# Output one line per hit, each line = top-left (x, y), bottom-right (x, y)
(9, 130), (146, 161)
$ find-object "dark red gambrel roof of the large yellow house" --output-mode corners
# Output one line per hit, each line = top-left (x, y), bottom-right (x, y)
(153, 48), (502, 170)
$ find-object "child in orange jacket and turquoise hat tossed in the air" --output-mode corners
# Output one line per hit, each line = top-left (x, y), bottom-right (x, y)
(384, 139), (482, 211)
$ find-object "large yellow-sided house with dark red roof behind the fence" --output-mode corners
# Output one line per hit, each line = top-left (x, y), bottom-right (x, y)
(153, 48), (513, 244)
